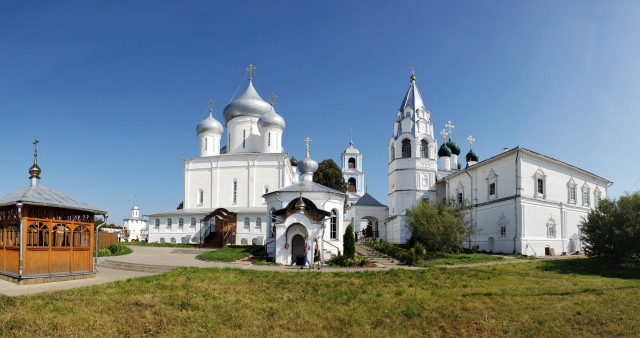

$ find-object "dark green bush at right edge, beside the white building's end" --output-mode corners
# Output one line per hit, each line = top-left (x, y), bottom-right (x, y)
(580, 192), (640, 265)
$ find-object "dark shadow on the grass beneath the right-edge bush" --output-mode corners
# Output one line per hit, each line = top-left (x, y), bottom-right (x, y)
(540, 258), (640, 279)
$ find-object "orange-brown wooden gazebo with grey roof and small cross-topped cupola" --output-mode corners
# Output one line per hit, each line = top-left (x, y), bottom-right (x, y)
(0, 144), (106, 284)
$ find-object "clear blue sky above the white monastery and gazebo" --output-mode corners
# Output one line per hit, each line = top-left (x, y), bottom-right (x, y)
(0, 1), (640, 224)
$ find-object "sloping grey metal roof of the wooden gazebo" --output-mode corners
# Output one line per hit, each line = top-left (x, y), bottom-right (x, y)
(0, 184), (106, 214)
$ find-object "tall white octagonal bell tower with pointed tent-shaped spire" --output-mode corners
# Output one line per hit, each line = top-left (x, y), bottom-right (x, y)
(386, 69), (438, 243)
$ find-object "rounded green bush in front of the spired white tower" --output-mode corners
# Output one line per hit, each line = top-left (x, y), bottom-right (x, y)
(407, 201), (471, 252)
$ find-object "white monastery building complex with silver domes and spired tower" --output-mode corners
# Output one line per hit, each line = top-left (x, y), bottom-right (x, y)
(136, 66), (611, 258)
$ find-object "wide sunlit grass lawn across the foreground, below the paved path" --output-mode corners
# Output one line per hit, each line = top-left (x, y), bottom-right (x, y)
(0, 259), (640, 337)
